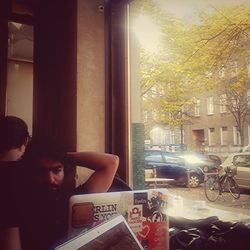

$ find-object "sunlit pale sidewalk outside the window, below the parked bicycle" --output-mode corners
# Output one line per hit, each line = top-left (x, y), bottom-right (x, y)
(148, 182), (250, 222)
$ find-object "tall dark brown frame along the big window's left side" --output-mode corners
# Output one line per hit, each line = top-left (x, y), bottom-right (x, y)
(105, 0), (130, 183)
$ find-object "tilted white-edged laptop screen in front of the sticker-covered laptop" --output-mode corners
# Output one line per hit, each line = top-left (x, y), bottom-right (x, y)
(55, 215), (143, 250)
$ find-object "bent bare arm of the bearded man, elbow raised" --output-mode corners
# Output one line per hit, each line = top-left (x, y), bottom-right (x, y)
(67, 152), (119, 193)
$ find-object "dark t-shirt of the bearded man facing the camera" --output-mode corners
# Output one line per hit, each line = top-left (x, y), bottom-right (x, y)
(20, 177), (86, 250)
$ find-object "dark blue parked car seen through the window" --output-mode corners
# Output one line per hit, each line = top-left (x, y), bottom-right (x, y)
(145, 150), (204, 187)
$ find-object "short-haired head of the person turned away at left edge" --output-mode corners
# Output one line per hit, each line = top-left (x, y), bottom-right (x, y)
(0, 116), (30, 160)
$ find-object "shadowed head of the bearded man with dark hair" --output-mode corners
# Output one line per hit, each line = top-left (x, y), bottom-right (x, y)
(24, 138), (67, 192)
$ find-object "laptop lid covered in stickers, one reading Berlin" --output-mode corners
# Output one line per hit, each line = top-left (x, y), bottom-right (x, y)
(68, 188), (169, 250)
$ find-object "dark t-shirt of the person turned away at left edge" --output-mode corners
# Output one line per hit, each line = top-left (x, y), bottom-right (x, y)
(0, 161), (23, 228)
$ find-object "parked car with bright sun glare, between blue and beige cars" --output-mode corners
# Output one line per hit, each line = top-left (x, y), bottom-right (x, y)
(180, 153), (222, 172)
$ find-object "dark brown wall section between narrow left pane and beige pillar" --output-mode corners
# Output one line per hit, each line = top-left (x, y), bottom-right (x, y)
(33, 0), (76, 150)
